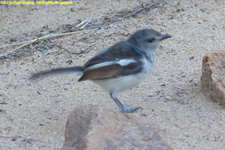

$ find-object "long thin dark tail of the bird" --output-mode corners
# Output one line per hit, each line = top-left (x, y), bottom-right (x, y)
(30, 66), (84, 80)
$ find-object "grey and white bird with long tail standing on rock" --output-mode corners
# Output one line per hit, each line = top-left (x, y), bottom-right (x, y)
(31, 29), (171, 113)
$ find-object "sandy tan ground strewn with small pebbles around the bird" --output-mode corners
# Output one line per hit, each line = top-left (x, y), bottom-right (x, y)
(0, 0), (225, 150)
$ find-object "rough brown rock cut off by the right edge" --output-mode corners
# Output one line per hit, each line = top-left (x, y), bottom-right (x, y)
(201, 51), (225, 105)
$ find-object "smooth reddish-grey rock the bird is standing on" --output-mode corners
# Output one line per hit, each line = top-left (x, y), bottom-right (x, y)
(62, 106), (172, 150)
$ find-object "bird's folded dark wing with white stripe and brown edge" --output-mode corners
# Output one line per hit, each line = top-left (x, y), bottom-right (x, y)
(79, 41), (143, 81)
